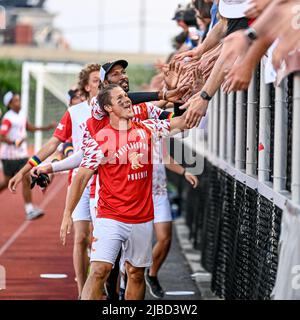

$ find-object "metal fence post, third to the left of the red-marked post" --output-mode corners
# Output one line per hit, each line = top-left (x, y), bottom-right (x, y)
(226, 93), (235, 164)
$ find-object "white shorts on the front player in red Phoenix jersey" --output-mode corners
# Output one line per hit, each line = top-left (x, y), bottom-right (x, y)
(91, 218), (153, 268)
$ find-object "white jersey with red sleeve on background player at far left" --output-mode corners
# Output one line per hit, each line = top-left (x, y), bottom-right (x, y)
(0, 110), (28, 160)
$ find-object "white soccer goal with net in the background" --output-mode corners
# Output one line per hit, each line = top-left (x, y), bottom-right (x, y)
(22, 62), (82, 151)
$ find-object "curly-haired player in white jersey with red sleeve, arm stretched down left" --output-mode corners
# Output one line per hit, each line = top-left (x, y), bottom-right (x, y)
(9, 64), (100, 296)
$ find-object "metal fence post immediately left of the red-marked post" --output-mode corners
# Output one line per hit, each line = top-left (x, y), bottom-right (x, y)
(246, 71), (258, 176)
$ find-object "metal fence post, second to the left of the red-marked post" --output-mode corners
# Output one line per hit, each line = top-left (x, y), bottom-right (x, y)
(235, 91), (246, 170)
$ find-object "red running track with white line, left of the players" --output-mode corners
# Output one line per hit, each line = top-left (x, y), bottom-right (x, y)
(0, 175), (77, 300)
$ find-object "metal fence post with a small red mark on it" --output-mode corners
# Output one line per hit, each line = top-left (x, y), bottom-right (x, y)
(258, 63), (271, 182)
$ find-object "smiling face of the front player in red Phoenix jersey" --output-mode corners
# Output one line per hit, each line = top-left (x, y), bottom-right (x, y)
(105, 87), (134, 120)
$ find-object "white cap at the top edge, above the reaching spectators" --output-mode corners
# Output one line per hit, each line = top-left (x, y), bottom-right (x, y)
(219, 0), (249, 19)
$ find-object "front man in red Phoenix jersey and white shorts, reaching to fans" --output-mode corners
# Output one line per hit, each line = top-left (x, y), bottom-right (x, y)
(61, 85), (186, 300)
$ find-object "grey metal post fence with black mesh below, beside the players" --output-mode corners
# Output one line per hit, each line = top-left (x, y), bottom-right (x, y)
(172, 64), (300, 299)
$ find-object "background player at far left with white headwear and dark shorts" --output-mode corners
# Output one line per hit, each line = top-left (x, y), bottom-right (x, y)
(0, 91), (56, 220)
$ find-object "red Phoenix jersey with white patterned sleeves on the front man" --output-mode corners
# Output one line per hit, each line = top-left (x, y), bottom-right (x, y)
(81, 120), (170, 223)
